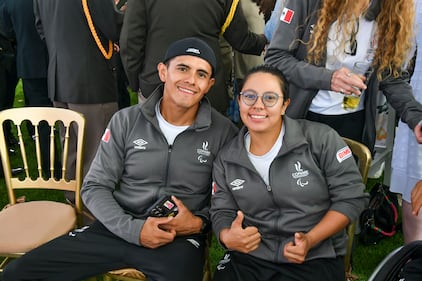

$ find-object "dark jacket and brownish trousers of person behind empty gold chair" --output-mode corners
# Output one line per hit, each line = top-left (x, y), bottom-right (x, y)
(33, 0), (119, 178)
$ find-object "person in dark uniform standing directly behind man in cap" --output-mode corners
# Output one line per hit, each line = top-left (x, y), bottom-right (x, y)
(120, 0), (267, 114)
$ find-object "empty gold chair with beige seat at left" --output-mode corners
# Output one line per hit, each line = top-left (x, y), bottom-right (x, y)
(0, 107), (85, 272)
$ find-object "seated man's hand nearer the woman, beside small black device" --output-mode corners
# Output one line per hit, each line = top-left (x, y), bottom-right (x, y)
(160, 196), (202, 236)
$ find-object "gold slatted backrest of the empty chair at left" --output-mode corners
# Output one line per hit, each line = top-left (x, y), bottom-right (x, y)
(0, 107), (85, 214)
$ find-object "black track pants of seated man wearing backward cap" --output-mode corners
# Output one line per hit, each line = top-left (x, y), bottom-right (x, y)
(3, 222), (206, 281)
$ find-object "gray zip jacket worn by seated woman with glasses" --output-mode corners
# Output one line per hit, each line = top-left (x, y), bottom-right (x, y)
(210, 117), (368, 263)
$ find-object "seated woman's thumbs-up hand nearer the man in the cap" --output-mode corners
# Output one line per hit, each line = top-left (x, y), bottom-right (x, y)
(220, 211), (261, 254)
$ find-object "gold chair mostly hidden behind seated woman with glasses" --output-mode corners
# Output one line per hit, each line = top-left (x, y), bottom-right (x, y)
(343, 138), (372, 279)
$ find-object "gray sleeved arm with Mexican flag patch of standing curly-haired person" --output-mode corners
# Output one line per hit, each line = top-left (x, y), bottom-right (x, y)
(265, 0), (333, 90)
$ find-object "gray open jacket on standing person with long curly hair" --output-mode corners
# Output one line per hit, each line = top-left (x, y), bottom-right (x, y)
(265, 0), (422, 151)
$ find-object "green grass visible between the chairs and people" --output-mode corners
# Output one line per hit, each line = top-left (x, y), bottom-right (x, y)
(0, 83), (403, 281)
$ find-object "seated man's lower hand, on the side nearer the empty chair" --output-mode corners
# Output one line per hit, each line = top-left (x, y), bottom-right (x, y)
(139, 217), (176, 249)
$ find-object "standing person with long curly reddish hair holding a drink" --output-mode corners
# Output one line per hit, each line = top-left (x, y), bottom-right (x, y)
(265, 0), (422, 151)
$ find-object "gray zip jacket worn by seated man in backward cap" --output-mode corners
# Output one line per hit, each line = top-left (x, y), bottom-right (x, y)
(81, 84), (237, 244)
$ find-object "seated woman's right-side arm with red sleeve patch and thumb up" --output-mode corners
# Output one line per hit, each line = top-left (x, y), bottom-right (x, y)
(284, 129), (368, 263)
